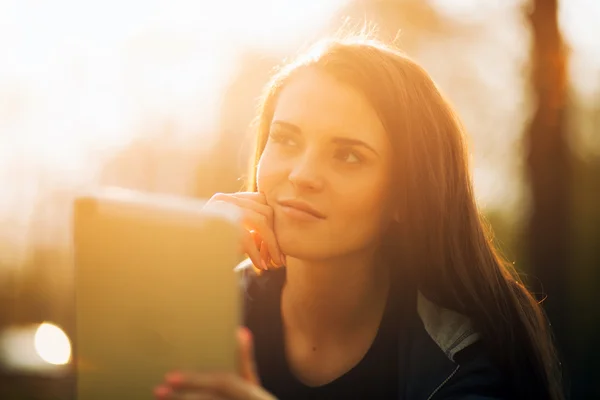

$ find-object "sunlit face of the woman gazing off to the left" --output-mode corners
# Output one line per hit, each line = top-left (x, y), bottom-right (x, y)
(257, 69), (392, 260)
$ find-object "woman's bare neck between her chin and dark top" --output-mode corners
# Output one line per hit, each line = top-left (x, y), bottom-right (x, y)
(281, 253), (390, 342)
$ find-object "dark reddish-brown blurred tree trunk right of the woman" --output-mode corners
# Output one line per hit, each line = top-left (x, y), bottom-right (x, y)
(524, 0), (572, 394)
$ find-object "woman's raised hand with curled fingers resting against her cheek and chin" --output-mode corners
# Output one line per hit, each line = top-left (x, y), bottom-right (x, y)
(205, 192), (285, 270)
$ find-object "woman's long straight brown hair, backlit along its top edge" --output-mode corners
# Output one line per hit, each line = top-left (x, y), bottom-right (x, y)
(248, 38), (563, 400)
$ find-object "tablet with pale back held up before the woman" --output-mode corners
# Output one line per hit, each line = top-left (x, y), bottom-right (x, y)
(73, 188), (242, 400)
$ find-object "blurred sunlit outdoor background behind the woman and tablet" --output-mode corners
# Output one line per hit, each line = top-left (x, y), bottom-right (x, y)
(0, 0), (600, 399)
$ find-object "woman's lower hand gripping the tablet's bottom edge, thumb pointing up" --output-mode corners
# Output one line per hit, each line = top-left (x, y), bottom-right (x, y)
(154, 328), (276, 400)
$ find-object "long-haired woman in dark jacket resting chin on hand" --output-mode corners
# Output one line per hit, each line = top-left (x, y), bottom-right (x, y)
(156, 36), (562, 400)
